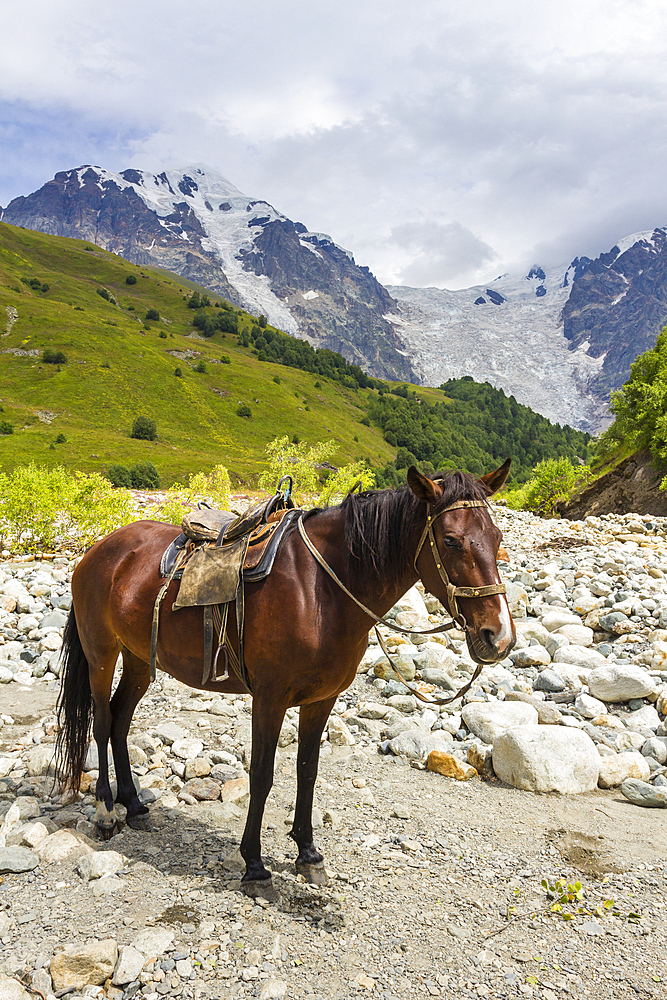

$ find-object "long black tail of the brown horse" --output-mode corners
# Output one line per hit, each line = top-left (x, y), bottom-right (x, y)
(56, 607), (93, 791)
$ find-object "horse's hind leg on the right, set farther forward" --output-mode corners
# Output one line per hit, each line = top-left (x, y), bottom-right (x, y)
(111, 647), (150, 826)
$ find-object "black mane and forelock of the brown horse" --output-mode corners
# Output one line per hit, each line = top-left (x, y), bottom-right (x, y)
(341, 472), (488, 586)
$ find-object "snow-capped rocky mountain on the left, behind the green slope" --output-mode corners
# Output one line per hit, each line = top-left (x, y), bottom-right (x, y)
(1, 164), (414, 379)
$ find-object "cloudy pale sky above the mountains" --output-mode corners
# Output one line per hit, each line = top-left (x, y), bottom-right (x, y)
(0, 0), (667, 288)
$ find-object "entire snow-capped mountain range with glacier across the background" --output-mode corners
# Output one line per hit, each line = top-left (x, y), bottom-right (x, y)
(0, 164), (667, 431)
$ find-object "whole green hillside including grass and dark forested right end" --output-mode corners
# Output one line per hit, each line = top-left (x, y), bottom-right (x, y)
(0, 223), (588, 485)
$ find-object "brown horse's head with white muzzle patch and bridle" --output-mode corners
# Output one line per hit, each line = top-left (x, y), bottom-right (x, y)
(408, 459), (516, 663)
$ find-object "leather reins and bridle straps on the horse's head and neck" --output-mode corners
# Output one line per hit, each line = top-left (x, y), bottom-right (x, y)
(297, 500), (506, 705)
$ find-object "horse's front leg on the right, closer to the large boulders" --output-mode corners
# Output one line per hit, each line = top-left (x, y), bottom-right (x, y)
(290, 697), (336, 882)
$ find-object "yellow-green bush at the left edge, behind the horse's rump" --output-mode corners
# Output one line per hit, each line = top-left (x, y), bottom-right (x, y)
(0, 463), (136, 552)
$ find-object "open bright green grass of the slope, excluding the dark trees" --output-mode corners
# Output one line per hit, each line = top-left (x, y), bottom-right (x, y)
(0, 223), (396, 483)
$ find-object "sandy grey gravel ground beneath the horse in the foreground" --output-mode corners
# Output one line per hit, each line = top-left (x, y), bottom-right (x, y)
(0, 678), (667, 1000)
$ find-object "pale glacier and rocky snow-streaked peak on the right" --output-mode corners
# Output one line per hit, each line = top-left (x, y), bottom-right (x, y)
(388, 229), (667, 432)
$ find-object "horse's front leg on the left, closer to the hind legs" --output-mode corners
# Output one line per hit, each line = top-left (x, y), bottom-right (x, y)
(241, 694), (285, 882)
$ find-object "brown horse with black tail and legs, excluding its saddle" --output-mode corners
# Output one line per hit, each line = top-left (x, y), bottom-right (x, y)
(58, 460), (516, 881)
